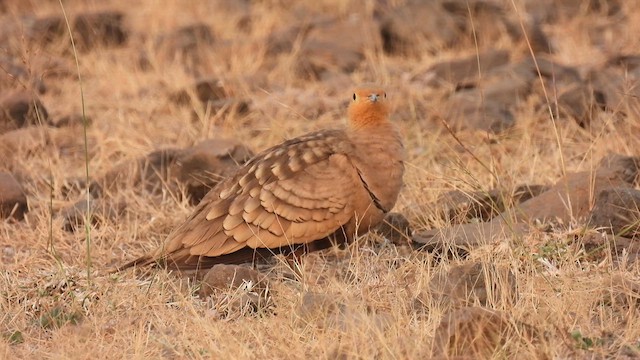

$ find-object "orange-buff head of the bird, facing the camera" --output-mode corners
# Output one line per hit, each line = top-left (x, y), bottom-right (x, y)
(349, 86), (389, 128)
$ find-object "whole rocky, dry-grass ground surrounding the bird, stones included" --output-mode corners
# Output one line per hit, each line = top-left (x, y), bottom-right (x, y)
(0, 0), (640, 359)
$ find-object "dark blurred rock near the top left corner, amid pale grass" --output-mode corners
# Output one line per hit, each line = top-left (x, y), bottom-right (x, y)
(73, 11), (128, 50)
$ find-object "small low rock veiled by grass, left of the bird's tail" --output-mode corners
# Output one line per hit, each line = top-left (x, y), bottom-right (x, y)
(60, 199), (127, 232)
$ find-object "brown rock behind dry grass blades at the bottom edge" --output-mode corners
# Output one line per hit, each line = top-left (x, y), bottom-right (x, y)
(431, 307), (550, 359)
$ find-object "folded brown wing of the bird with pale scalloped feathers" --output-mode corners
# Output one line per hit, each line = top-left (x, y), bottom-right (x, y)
(154, 131), (359, 263)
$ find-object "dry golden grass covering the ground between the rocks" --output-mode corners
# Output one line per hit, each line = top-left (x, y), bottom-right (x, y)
(0, 0), (640, 359)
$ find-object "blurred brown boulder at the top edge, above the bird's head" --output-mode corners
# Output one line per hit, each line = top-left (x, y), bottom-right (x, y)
(380, 1), (460, 56)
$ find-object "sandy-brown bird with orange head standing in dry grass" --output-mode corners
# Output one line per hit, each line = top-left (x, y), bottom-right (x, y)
(116, 86), (405, 271)
